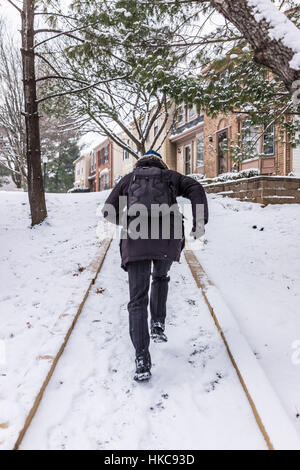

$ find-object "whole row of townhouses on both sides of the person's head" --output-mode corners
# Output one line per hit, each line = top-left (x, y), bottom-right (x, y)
(74, 105), (300, 191)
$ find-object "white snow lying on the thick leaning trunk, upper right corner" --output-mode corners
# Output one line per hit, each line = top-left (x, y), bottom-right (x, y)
(248, 0), (300, 70)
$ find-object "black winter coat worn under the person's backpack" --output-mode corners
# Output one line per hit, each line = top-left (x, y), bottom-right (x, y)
(103, 157), (208, 270)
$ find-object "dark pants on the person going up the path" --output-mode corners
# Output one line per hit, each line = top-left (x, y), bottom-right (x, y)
(127, 260), (172, 358)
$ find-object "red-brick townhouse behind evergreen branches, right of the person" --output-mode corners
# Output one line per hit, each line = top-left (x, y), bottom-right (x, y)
(168, 105), (300, 178)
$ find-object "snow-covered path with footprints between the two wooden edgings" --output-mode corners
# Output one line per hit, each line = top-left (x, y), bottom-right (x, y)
(21, 241), (266, 449)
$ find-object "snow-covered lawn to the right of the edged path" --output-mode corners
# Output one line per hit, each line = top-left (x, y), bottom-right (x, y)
(200, 195), (300, 433)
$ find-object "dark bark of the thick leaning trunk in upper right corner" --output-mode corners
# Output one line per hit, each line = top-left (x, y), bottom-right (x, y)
(210, 0), (300, 92)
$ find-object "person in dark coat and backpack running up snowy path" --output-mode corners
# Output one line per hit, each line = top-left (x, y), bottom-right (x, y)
(103, 150), (208, 381)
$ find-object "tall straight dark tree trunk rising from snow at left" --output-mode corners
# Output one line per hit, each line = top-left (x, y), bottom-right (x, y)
(22, 0), (47, 225)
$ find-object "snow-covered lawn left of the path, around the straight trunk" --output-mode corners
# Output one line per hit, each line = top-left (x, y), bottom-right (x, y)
(0, 192), (105, 448)
